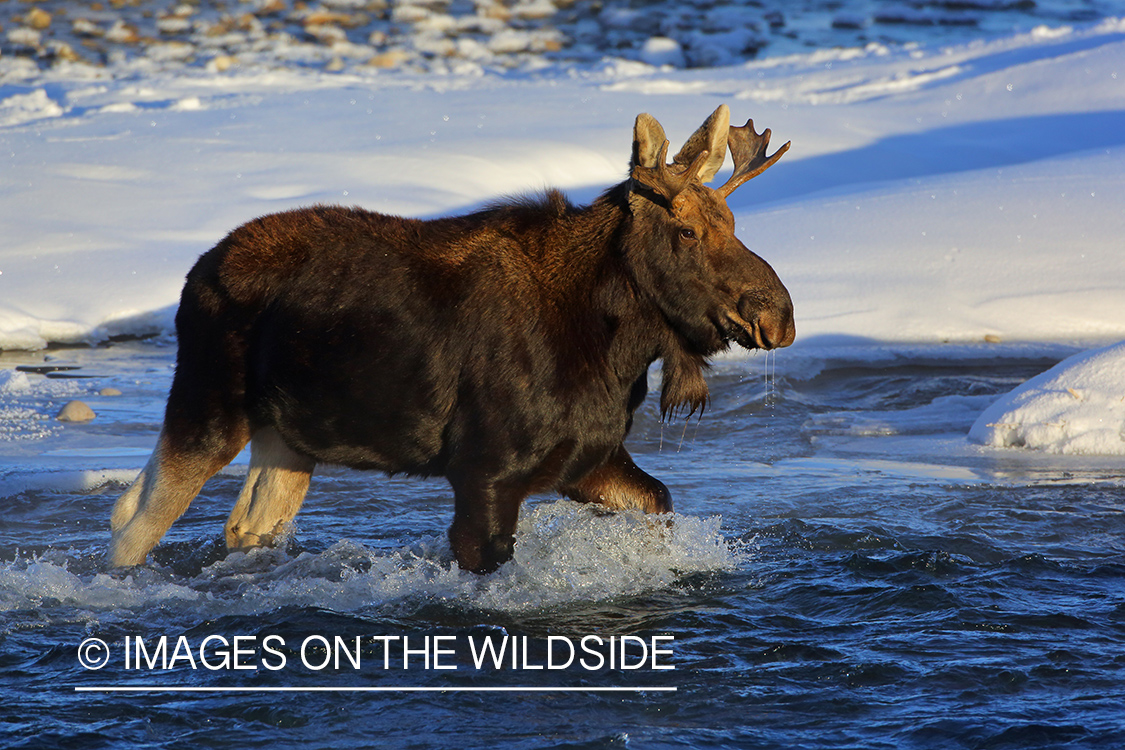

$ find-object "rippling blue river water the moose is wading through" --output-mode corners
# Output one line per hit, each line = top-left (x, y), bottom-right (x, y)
(0, 344), (1125, 750)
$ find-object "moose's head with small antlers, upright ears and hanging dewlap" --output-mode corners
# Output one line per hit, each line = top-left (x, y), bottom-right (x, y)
(627, 105), (797, 413)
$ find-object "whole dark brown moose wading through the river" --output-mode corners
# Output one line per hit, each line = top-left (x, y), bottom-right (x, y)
(109, 105), (795, 573)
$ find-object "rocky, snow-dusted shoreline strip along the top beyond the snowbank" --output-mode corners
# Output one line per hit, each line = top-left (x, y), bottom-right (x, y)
(0, 0), (1096, 80)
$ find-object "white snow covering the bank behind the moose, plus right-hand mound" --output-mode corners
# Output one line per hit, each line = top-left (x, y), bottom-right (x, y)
(0, 14), (1125, 453)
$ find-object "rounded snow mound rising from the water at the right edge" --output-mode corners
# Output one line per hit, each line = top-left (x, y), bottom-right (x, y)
(969, 341), (1125, 455)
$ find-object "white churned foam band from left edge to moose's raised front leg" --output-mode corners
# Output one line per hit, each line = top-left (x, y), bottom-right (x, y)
(0, 500), (745, 616)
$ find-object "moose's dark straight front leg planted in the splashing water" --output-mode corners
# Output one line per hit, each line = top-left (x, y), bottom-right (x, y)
(449, 481), (528, 573)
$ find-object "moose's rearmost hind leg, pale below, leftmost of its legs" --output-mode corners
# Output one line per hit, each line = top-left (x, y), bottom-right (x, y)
(109, 430), (244, 568)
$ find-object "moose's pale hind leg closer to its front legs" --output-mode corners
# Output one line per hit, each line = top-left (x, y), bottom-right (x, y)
(226, 427), (316, 550)
